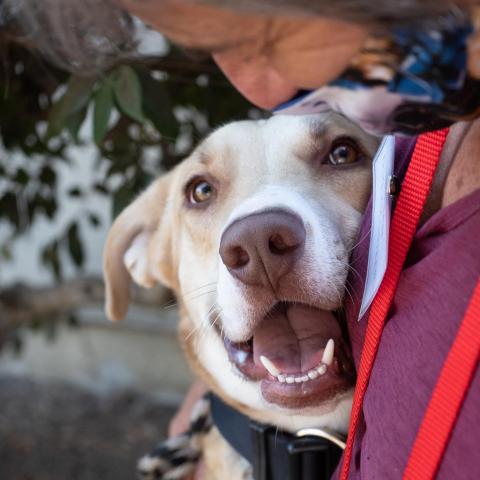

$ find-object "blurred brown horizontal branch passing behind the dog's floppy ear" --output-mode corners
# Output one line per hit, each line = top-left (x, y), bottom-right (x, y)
(0, 277), (172, 345)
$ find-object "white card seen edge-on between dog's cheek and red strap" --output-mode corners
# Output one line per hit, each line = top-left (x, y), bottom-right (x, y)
(358, 135), (395, 320)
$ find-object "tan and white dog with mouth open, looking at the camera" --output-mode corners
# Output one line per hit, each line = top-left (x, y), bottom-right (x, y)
(104, 113), (379, 480)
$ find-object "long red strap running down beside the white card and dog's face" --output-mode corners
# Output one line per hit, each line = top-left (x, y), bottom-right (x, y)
(340, 129), (448, 480)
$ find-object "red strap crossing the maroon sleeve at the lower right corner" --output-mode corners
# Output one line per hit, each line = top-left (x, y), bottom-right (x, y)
(403, 281), (480, 480)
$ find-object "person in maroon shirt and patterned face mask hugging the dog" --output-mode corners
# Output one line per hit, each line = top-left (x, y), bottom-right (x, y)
(4, 0), (480, 479)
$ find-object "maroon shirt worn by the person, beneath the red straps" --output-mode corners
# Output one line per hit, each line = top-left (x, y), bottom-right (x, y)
(334, 140), (480, 480)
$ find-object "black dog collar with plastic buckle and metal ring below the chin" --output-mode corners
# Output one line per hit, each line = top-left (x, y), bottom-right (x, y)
(210, 394), (345, 480)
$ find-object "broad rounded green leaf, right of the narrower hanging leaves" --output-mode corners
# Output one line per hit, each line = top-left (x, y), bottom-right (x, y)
(113, 65), (144, 123)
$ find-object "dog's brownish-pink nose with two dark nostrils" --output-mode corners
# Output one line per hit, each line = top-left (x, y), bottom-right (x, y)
(220, 210), (306, 288)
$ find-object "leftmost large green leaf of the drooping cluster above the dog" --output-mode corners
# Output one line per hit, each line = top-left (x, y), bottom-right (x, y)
(47, 76), (96, 138)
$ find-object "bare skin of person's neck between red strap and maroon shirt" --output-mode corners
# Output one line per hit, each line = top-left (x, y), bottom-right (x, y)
(421, 120), (480, 223)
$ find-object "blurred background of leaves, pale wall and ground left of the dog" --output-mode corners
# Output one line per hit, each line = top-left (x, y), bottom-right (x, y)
(0, 13), (261, 480)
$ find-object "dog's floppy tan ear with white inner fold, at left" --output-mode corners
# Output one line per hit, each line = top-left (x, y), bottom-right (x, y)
(103, 174), (171, 320)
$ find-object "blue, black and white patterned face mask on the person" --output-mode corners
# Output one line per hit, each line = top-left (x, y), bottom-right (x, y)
(275, 13), (480, 135)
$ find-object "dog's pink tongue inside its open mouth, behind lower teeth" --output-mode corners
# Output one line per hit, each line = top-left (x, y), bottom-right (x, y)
(253, 304), (341, 373)
